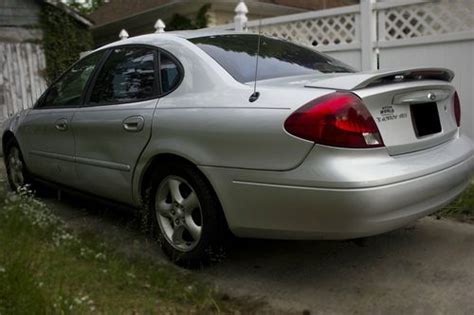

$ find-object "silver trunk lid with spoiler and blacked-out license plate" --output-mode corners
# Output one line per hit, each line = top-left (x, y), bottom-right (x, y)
(305, 68), (458, 155)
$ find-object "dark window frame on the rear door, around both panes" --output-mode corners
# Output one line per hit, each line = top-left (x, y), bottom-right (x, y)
(79, 44), (184, 108)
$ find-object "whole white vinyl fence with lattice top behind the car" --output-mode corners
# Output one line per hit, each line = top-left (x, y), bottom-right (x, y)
(223, 0), (474, 139)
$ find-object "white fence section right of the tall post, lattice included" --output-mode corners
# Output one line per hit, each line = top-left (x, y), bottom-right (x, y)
(376, 0), (474, 139)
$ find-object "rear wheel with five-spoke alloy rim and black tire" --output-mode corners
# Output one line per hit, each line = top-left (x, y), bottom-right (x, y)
(146, 164), (229, 268)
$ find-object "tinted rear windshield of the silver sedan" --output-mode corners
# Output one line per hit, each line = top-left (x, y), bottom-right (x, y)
(190, 34), (354, 83)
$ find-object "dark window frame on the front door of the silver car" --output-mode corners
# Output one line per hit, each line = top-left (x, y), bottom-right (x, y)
(32, 49), (108, 109)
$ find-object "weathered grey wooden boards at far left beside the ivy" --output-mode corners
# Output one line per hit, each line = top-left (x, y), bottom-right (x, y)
(0, 0), (46, 132)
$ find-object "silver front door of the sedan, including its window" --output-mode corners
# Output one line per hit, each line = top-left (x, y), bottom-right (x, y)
(17, 52), (103, 186)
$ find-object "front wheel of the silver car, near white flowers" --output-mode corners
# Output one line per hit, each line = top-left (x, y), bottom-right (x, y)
(4, 139), (33, 192)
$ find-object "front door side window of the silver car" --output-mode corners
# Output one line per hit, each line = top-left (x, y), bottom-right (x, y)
(39, 52), (103, 107)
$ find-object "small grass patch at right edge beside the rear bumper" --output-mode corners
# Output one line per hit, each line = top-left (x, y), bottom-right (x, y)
(436, 182), (474, 223)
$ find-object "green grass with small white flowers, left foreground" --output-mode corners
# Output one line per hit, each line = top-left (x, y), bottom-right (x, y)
(0, 185), (256, 314)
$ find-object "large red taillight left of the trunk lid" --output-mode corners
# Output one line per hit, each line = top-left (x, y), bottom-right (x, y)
(285, 92), (383, 148)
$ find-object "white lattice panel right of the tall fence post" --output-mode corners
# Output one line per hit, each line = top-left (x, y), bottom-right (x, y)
(378, 0), (474, 41)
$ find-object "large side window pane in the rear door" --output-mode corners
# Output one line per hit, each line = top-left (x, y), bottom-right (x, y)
(89, 47), (157, 105)
